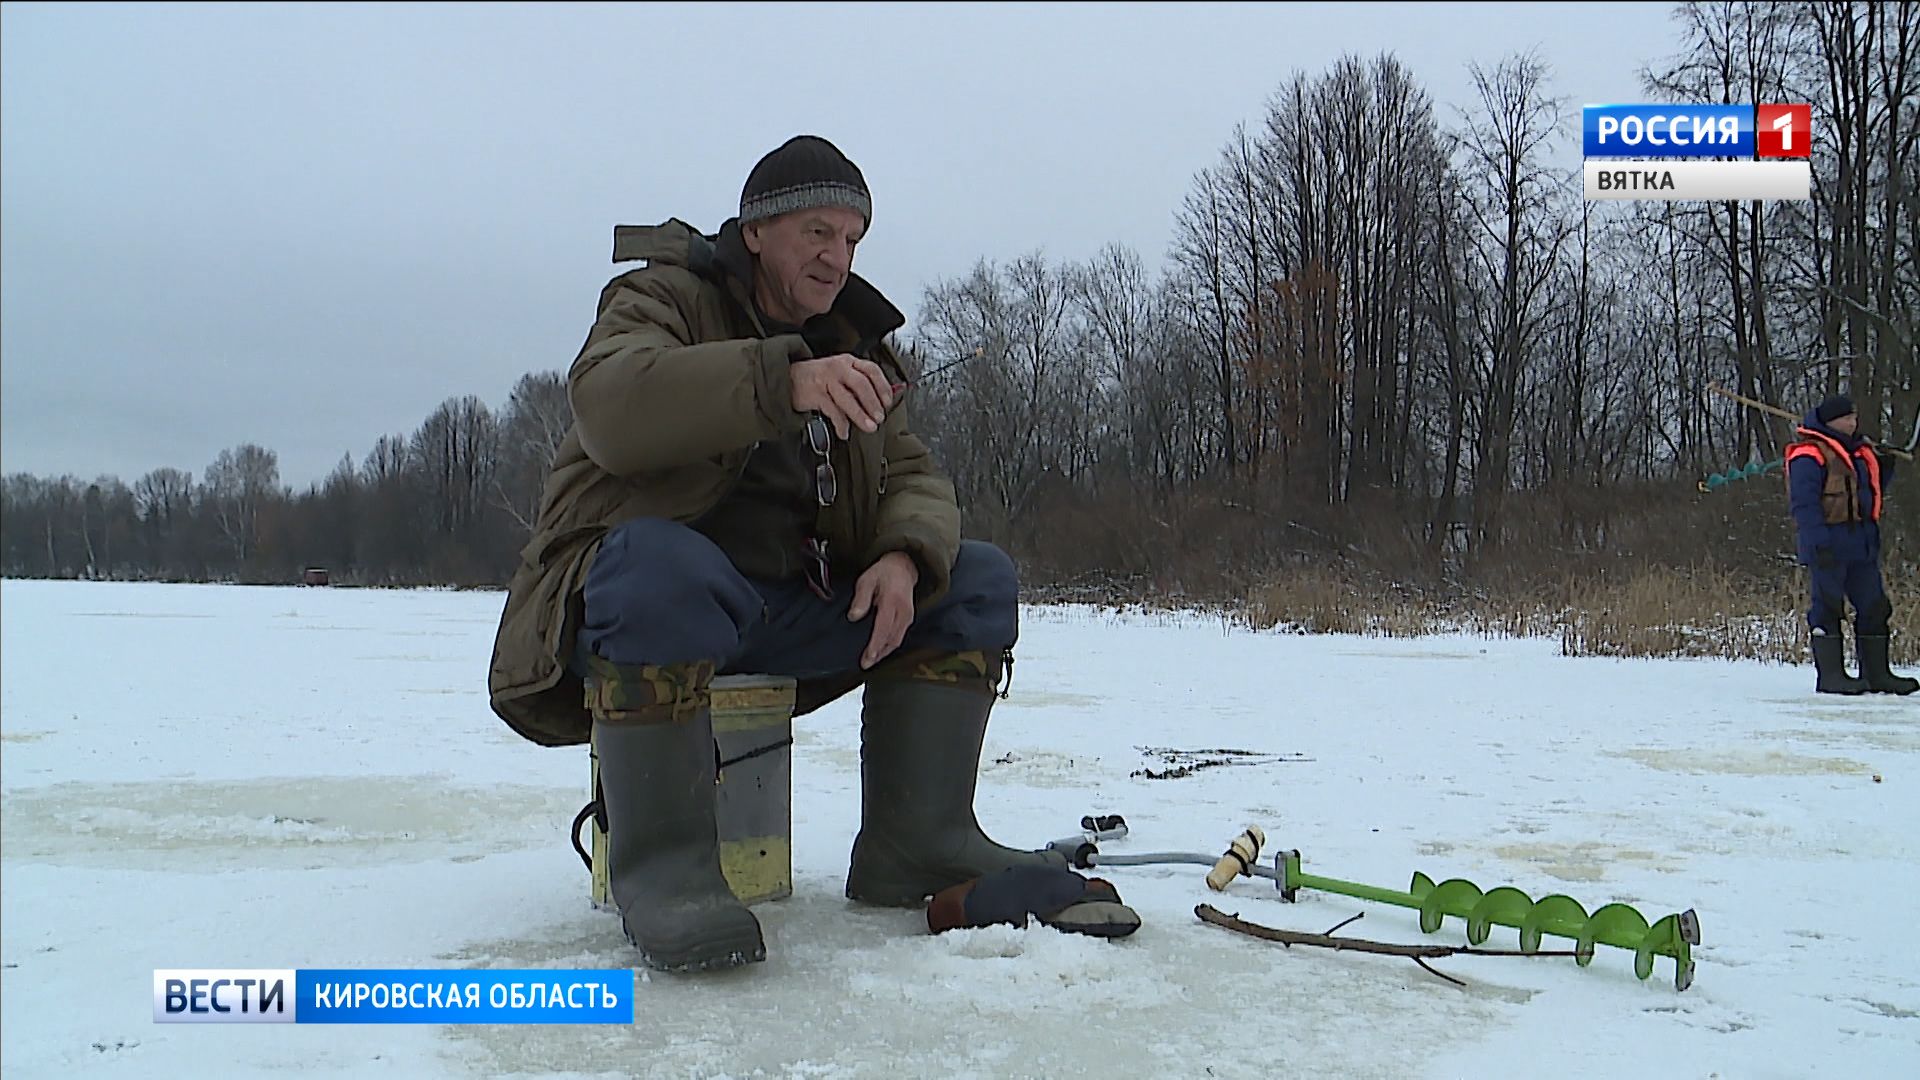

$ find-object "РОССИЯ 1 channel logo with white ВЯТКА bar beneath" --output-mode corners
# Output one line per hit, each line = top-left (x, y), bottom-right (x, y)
(1580, 104), (1812, 200)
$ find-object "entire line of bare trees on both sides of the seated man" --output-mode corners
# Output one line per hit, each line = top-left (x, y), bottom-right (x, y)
(0, 2), (1920, 586)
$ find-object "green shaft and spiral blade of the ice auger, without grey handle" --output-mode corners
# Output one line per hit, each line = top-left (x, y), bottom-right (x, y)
(1260, 849), (1699, 990)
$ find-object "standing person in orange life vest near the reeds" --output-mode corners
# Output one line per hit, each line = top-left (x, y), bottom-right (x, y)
(1786, 394), (1920, 694)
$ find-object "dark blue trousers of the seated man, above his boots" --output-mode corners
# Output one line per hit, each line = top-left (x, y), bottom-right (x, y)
(576, 517), (1020, 678)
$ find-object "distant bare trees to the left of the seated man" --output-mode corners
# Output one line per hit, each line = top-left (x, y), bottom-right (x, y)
(0, 371), (572, 584)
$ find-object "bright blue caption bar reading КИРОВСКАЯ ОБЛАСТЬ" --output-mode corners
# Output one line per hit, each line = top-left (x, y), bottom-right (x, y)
(294, 969), (634, 1024)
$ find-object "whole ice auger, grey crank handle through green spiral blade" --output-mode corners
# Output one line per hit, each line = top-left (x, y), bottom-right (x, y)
(1046, 815), (1699, 990)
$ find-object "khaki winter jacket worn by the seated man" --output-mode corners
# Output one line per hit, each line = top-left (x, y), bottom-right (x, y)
(488, 219), (960, 746)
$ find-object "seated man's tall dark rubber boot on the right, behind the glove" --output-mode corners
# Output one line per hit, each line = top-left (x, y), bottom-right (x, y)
(847, 651), (1068, 907)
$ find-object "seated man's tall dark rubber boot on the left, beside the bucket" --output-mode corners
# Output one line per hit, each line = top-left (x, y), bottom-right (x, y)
(588, 657), (766, 970)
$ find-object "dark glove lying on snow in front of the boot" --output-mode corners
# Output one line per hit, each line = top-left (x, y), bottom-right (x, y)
(927, 867), (1140, 938)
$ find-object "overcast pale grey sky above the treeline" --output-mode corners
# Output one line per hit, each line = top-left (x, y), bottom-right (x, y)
(0, 4), (1676, 488)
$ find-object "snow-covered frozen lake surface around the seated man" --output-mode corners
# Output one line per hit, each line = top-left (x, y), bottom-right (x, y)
(0, 580), (1920, 1080)
